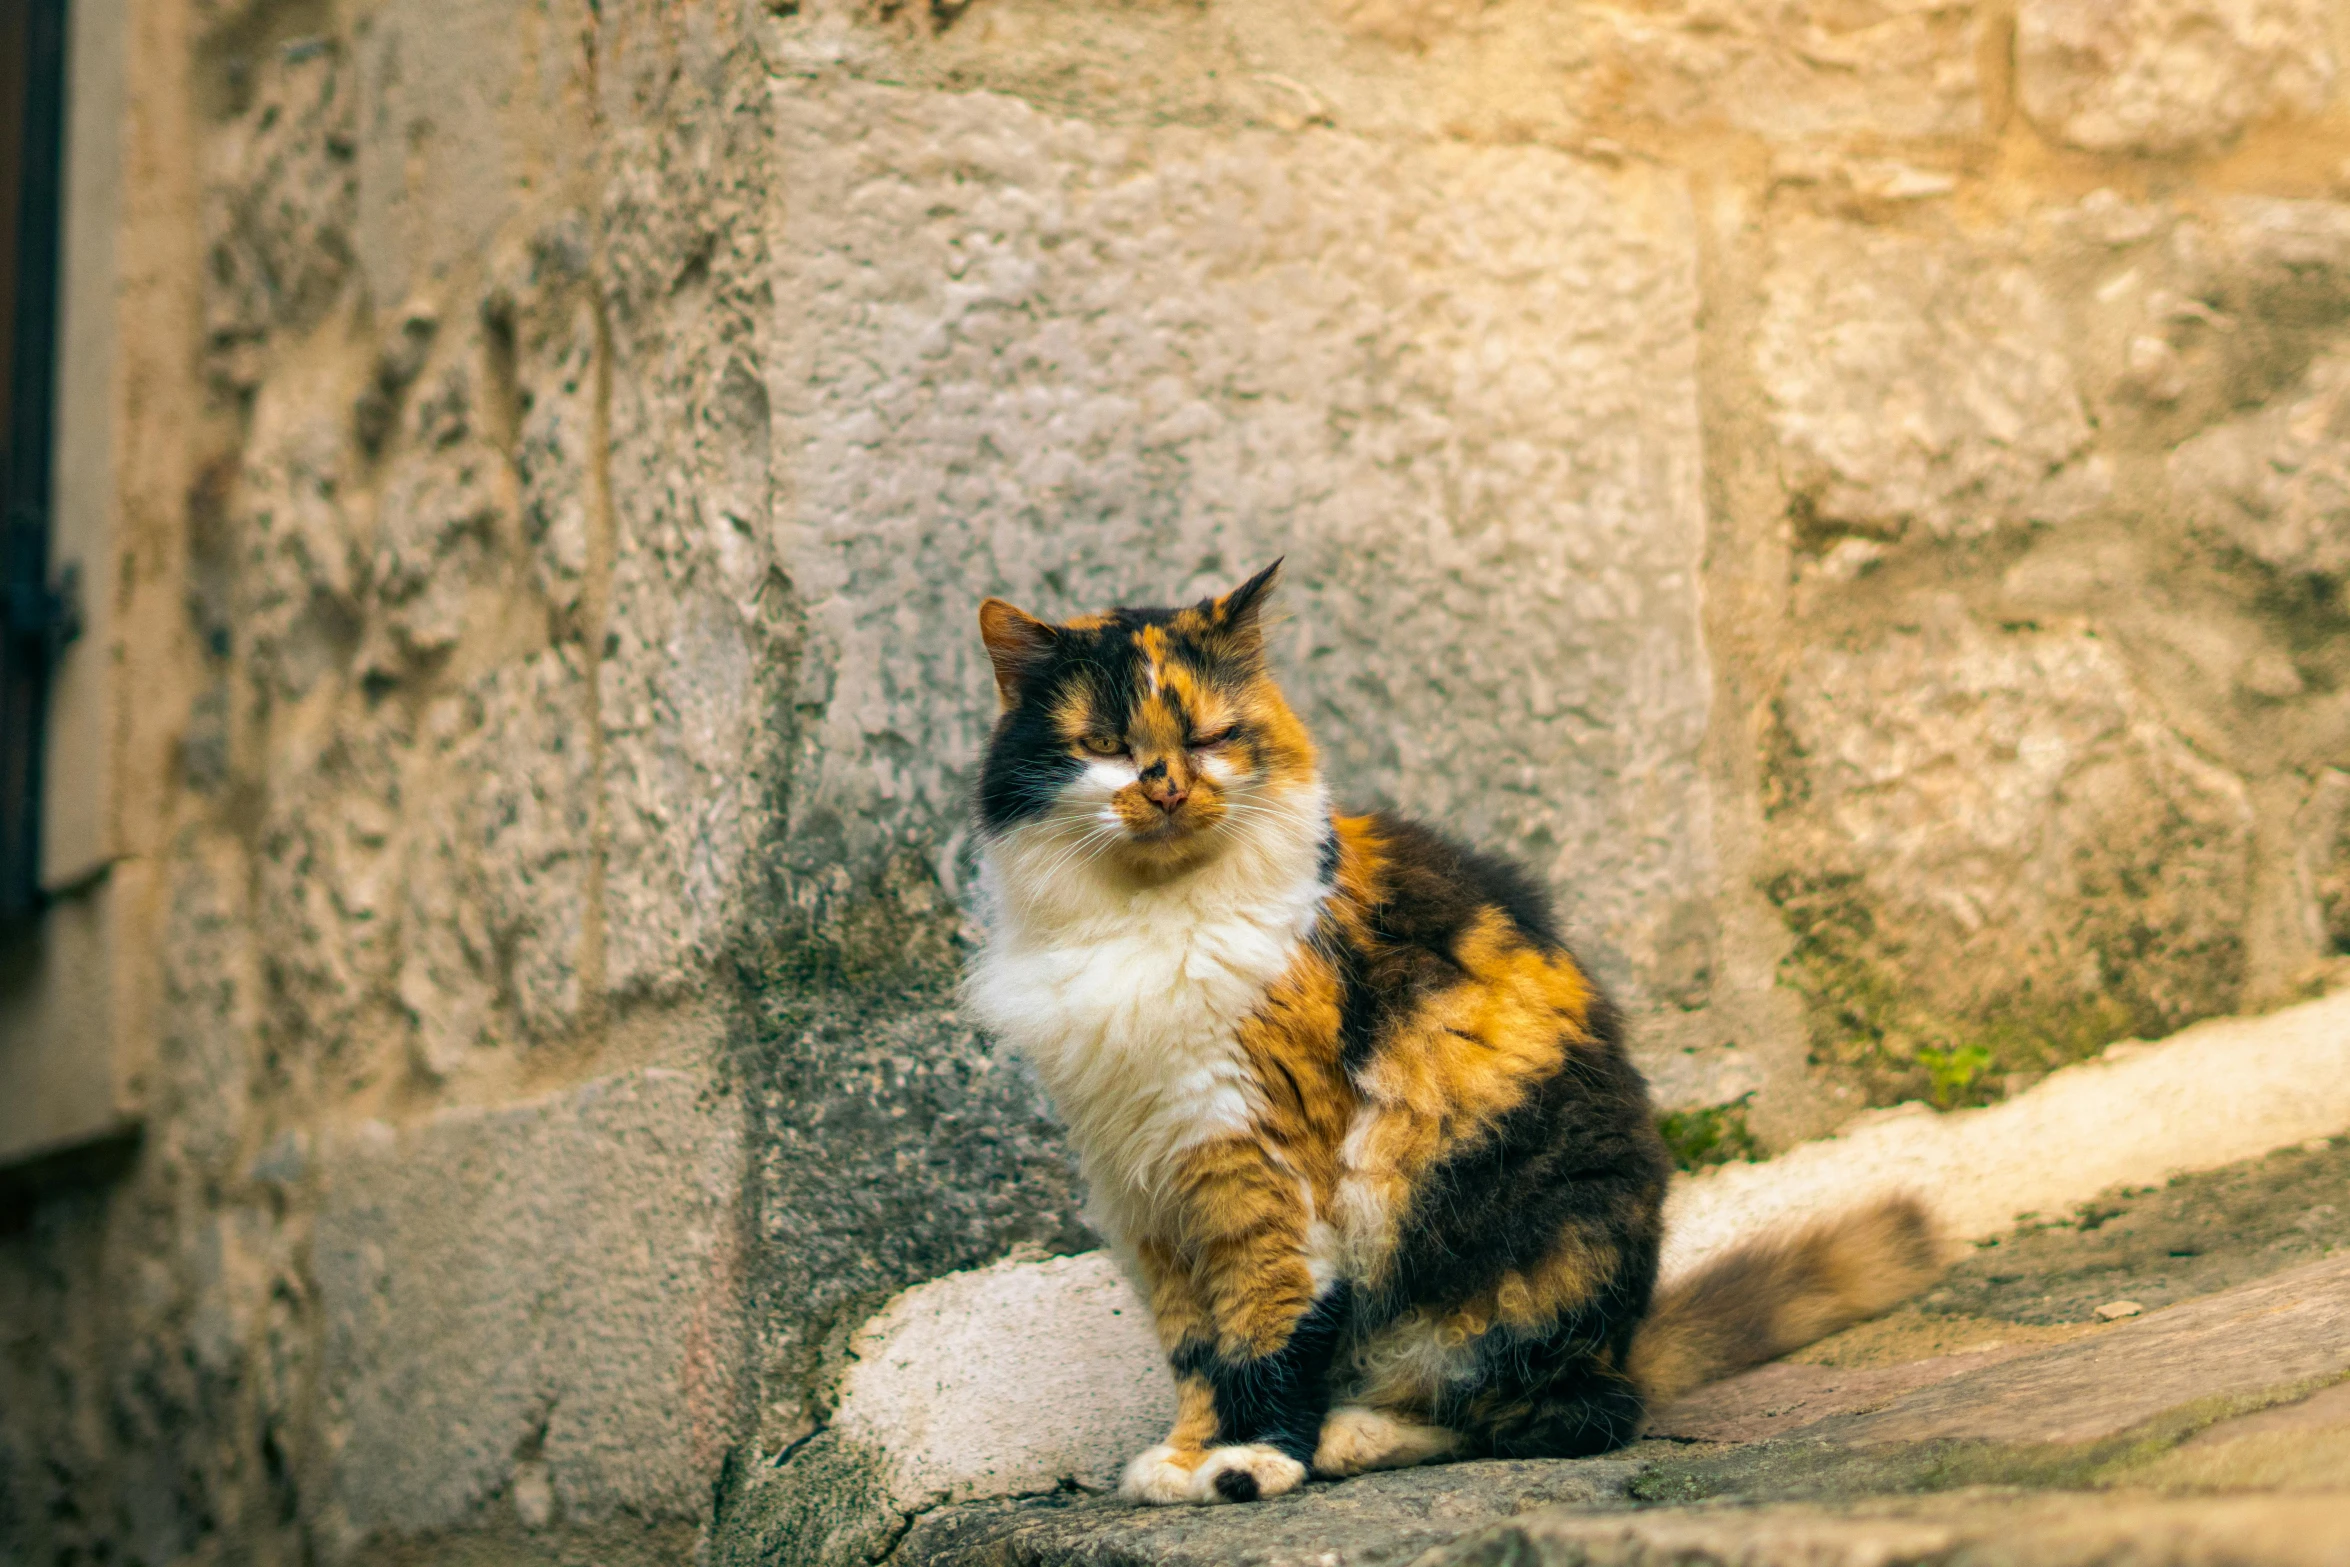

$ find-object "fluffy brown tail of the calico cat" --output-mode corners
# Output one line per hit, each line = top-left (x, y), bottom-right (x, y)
(1629, 1196), (1943, 1410)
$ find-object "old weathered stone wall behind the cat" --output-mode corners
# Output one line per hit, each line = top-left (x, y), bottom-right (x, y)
(0, 0), (2350, 1562)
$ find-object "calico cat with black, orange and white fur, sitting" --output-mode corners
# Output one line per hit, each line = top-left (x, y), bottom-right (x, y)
(964, 561), (1936, 1504)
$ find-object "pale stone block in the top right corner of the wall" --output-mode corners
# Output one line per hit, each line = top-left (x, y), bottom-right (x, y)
(2016, 0), (2336, 153)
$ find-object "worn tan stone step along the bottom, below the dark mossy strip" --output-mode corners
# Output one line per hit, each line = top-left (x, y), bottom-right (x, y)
(891, 1255), (2350, 1567)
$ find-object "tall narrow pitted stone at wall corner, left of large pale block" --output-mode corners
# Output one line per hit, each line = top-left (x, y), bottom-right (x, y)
(597, 61), (794, 994)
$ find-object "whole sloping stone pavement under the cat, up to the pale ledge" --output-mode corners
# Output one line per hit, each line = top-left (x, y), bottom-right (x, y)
(893, 1139), (2350, 1567)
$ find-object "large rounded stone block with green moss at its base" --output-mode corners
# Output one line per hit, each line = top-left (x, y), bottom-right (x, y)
(1772, 599), (2251, 1097)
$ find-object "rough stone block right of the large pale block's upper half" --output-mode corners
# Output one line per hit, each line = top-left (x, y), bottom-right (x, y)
(1755, 216), (2110, 538)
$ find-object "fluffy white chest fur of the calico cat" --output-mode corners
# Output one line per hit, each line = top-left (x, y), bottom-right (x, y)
(964, 789), (1328, 1243)
